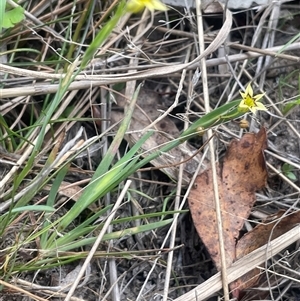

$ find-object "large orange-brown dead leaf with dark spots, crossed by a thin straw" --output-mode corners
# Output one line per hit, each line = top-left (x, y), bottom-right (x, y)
(189, 128), (267, 270)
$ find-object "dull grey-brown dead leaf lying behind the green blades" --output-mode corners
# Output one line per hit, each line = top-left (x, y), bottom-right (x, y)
(111, 90), (208, 186)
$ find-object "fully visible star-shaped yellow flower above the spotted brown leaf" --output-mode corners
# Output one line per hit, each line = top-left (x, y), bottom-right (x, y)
(238, 83), (267, 114)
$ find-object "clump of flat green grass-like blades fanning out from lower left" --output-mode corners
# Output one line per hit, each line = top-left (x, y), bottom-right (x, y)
(0, 1), (251, 277)
